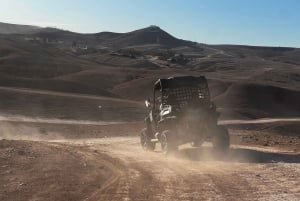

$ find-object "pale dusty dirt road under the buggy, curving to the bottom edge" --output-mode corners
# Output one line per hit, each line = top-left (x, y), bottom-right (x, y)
(50, 137), (300, 201)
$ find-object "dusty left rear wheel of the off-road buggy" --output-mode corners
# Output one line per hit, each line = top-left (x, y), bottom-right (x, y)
(160, 130), (177, 155)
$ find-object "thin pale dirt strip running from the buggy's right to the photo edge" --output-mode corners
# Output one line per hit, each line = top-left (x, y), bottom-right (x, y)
(218, 118), (300, 125)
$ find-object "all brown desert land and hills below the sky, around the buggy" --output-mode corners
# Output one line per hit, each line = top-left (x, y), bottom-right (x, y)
(0, 23), (300, 201)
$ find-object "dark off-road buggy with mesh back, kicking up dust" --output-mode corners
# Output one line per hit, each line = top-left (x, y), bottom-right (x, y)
(140, 76), (229, 154)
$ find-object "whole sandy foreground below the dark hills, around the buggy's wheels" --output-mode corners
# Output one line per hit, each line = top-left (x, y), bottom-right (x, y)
(0, 121), (300, 200)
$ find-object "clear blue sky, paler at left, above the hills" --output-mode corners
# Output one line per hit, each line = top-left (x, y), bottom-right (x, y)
(0, 0), (300, 47)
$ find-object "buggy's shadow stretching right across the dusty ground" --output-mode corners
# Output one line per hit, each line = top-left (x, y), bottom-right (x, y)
(176, 147), (300, 163)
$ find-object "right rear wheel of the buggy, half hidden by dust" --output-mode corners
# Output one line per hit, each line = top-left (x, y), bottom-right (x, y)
(212, 126), (230, 153)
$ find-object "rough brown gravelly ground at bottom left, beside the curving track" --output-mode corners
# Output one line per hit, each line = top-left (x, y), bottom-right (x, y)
(0, 140), (116, 200)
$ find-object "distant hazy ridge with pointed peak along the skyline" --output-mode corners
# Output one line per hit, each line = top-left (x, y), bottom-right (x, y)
(0, 23), (195, 48)
